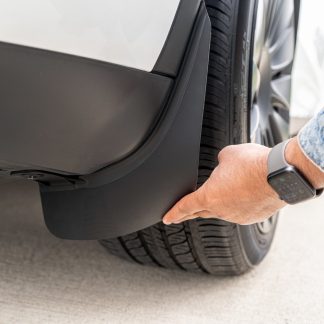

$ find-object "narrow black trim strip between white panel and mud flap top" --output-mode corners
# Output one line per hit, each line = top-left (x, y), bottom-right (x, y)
(152, 0), (201, 77)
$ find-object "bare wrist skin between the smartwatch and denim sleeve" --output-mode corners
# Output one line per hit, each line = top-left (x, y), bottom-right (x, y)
(285, 137), (324, 189)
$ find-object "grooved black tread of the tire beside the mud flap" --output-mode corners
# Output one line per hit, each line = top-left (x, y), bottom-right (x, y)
(101, 0), (249, 275)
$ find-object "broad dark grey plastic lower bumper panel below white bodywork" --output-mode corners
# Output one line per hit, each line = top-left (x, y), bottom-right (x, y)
(0, 42), (173, 174)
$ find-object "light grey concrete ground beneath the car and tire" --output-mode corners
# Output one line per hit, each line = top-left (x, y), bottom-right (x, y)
(0, 183), (324, 324)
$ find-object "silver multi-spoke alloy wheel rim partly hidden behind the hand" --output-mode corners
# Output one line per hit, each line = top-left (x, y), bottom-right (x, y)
(250, 0), (295, 234)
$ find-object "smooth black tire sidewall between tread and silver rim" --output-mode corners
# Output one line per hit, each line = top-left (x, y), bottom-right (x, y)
(231, 0), (277, 266)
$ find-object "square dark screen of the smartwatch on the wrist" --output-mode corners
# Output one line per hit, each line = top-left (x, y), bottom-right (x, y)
(268, 168), (316, 204)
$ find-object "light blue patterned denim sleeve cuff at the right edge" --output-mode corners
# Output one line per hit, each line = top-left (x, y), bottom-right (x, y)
(298, 109), (324, 172)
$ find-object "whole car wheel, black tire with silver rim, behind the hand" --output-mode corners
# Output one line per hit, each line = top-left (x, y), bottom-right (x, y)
(101, 0), (296, 275)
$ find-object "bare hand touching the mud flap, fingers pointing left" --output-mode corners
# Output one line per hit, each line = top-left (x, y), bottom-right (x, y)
(163, 144), (286, 225)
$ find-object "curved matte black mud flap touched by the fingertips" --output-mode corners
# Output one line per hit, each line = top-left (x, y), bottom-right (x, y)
(40, 6), (211, 239)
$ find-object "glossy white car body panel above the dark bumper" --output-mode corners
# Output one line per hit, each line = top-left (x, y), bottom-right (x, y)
(0, 0), (180, 71)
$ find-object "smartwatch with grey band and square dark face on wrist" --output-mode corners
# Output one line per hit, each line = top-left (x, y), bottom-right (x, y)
(268, 140), (323, 205)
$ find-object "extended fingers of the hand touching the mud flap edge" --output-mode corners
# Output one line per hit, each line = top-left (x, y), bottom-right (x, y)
(163, 187), (205, 225)
